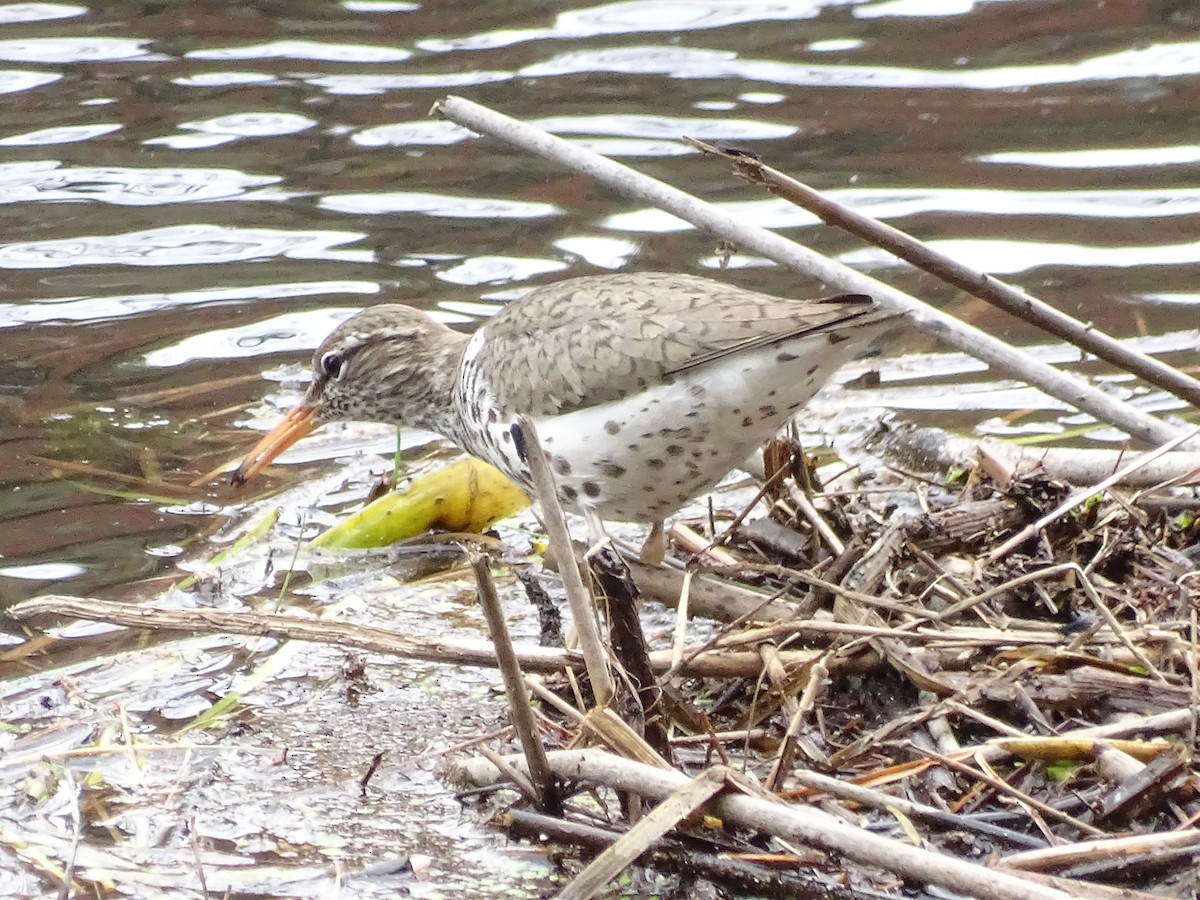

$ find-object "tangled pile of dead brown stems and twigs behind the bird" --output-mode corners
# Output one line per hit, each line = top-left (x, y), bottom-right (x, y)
(464, 445), (1200, 898)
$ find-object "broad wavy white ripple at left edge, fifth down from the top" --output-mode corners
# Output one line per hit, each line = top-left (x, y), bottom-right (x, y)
(0, 162), (280, 206)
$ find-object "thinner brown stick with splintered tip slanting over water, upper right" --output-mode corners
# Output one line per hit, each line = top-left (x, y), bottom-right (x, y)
(686, 138), (1200, 407)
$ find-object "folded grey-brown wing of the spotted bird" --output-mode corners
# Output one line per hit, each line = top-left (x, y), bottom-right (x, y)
(475, 272), (880, 415)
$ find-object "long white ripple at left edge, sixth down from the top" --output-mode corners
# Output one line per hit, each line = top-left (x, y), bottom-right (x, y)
(0, 224), (373, 269)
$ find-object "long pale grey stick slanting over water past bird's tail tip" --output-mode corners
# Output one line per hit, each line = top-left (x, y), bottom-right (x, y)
(432, 96), (1195, 446)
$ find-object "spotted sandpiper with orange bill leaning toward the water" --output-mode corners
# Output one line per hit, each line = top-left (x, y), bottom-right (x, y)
(234, 272), (894, 556)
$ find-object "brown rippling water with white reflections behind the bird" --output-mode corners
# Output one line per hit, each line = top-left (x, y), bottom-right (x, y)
(0, 0), (1200, 893)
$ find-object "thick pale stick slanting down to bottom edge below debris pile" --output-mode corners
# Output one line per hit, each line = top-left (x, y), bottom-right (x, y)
(456, 750), (1085, 900)
